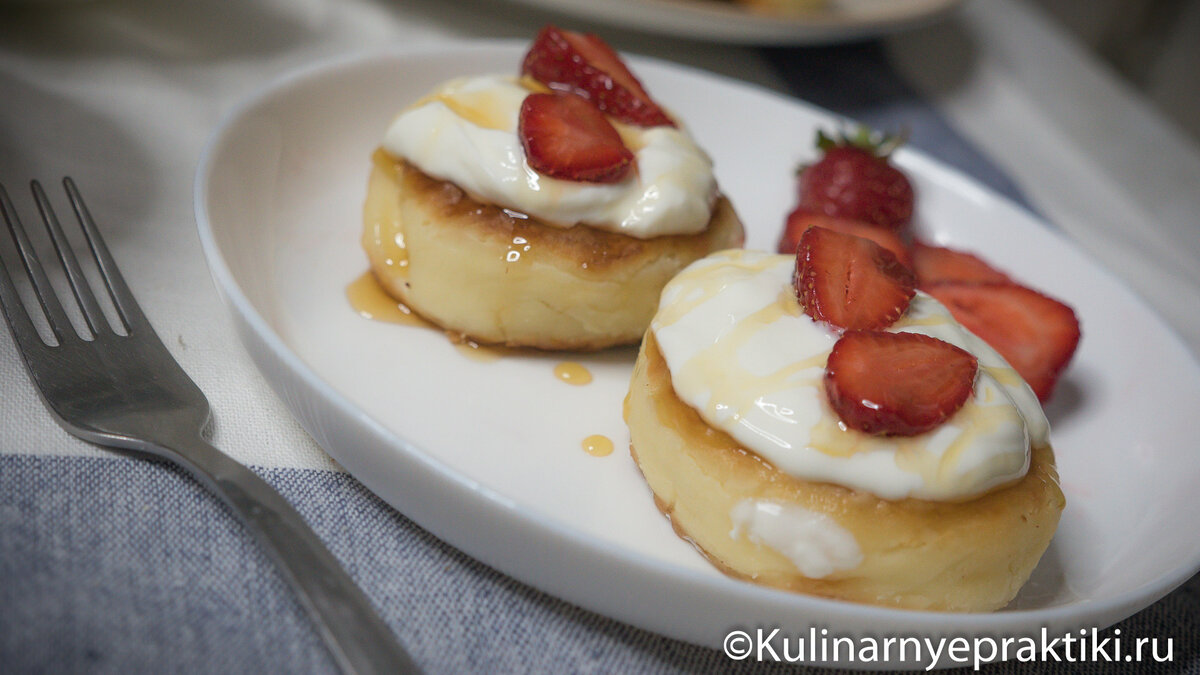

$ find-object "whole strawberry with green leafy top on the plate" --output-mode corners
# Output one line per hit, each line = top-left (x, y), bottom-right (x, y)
(799, 129), (913, 231)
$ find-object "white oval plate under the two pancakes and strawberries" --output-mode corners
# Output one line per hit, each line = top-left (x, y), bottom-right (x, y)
(196, 43), (1200, 667)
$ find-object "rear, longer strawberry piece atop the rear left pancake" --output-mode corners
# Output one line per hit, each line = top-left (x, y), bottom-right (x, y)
(521, 25), (676, 126)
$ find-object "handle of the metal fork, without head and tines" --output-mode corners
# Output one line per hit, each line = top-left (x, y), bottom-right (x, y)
(170, 437), (420, 674)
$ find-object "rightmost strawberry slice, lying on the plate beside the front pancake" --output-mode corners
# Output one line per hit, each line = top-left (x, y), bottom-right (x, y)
(925, 282), (1080, 401)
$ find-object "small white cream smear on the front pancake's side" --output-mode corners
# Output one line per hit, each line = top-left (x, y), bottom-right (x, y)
(730, 500), (863, 579)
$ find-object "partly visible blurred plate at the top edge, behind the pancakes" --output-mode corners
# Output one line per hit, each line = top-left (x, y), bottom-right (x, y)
(501, 0), (961, 44)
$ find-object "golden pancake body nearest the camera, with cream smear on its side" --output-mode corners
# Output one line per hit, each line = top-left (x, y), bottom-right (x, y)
(625, 331), (1064, 611)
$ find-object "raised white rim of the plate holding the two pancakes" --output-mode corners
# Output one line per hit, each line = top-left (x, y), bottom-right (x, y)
(193, 40), (1200, 665)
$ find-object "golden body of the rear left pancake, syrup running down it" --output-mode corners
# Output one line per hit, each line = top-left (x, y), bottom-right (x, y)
(362, 149), (744, 350)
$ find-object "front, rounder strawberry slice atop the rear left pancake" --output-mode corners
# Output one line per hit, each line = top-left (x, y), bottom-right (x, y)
(517, 92), (634, 183)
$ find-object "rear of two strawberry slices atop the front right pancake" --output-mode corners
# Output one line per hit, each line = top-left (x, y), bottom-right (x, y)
(792, 227), (917, 329)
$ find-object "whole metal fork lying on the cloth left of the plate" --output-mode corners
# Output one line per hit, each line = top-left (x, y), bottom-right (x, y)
(0, 178), (418, 673)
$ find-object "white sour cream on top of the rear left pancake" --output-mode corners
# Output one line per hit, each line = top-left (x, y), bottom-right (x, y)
(383, 76), (716, 239)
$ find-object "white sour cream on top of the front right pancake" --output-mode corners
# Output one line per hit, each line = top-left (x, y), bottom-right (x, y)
(650, 251), (1050, 501)
